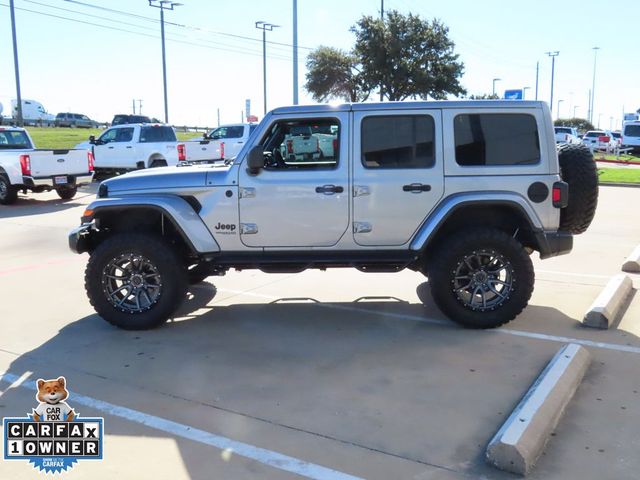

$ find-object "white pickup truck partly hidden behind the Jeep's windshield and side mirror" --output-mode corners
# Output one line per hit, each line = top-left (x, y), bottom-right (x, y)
(184, 123), (258, 163)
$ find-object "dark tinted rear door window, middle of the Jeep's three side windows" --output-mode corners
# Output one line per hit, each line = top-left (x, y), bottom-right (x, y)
(361, 115), (435, 168)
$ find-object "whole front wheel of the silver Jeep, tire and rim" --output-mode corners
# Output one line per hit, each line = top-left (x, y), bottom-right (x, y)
(85, 233), (187, 330)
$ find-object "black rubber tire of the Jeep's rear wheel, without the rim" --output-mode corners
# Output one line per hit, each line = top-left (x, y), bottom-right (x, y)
(427, 228), (535, 328)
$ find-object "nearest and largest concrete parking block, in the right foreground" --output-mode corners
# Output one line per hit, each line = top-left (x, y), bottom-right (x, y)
(486, 343), (591, 475)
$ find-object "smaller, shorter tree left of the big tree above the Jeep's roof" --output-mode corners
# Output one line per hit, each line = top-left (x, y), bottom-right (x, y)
(305, 47), (371, 102)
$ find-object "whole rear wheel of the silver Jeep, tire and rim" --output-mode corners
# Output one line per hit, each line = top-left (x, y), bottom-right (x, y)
(428, 228), (534, 328)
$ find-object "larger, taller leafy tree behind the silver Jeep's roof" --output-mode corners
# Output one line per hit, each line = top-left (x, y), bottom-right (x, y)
(351, 10), (466, 100)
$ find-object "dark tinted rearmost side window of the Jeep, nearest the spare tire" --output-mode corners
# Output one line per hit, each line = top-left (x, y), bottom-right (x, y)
(454, 113), (540, 166)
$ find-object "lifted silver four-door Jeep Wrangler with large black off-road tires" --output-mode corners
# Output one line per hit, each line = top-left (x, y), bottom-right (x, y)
(69, 101), (598, 329)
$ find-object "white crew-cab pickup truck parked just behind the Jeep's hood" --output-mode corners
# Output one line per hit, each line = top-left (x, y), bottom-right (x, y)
(76, 123), (185, 175)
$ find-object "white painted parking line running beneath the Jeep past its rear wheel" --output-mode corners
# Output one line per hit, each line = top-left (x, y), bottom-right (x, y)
(218, 288), (640, 353)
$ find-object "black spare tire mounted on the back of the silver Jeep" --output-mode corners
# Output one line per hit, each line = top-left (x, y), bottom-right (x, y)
(558, 144), (598, 234)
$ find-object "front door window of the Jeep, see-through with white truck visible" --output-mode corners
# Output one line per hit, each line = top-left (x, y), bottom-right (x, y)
(261, 118), (340, 170)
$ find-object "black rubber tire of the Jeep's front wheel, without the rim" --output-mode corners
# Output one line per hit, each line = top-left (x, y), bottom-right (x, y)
(85, 233), (187, 330)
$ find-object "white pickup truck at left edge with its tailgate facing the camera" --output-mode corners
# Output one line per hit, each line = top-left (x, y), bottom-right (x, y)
(0, 127), (93, 205)
